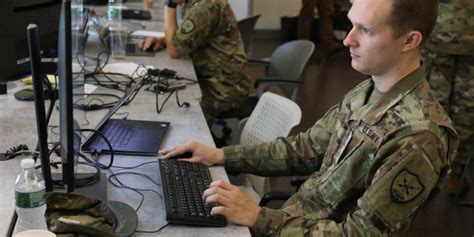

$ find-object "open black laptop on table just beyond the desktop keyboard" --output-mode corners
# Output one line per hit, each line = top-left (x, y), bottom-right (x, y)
(82, 80), (170, 156)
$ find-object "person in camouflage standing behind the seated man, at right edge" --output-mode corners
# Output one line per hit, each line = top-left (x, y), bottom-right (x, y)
(424, 0), (474, 194)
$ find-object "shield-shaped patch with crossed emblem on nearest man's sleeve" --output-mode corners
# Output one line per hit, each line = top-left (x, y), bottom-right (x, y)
(390, 169), (425, 203)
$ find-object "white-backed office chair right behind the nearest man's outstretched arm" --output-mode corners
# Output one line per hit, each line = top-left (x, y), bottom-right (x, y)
(231, 92), (301, 202)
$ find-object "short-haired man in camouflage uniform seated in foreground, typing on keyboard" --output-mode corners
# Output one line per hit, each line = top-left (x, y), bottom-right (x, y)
(160, 0), (458, 236)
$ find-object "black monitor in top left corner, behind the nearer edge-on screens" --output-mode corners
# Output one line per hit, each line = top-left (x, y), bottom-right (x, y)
(0, 0), (61, 82)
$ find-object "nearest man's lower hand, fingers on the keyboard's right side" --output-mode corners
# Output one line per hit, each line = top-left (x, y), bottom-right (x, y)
(203, 180), (260, 227)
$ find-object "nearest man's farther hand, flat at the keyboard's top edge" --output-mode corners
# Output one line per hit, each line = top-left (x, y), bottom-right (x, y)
(160, 141), (224, 166)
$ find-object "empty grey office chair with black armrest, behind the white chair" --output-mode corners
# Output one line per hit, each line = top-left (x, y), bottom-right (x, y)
(215, 40), (314, 145)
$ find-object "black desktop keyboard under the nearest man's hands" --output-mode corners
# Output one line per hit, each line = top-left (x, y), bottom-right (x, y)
(159, 159), (226, 227)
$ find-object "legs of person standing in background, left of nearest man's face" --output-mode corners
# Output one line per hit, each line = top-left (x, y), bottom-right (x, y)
(298, 0), (344, 56)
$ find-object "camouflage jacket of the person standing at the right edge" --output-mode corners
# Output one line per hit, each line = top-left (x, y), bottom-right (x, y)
(426, 0), (474, 55)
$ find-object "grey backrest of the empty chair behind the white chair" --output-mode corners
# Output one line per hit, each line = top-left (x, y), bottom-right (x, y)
(266, 40), (314, 101)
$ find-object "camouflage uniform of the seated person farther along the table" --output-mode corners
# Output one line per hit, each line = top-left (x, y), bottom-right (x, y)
(173, 0), (250, 124)
